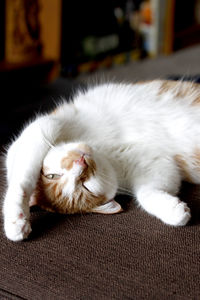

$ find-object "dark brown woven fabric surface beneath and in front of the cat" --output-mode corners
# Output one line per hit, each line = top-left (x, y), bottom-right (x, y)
(0, 161), (200, 300)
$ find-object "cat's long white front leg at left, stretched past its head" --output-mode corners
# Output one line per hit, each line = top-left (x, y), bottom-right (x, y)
(3, 115), (63, 241)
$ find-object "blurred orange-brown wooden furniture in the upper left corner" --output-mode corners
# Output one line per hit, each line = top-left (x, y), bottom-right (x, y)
(0, 0), (61, 83)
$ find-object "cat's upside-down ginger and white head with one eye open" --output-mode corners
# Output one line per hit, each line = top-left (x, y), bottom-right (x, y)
(32, 143), (122, 214)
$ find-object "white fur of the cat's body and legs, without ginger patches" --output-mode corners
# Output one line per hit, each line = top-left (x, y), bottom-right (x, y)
(3, 81), (200, 241)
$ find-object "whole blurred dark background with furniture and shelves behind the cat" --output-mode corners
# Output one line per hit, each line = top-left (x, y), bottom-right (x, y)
(0, 0), (200, 144)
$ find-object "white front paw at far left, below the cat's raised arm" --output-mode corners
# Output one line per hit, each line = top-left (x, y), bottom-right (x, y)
(4, 213), (32, 242)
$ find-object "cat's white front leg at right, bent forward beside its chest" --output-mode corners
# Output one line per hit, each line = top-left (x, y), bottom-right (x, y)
(134, 159), (191, 226)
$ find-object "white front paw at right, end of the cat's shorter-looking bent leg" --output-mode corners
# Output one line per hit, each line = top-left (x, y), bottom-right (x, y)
(162, 202), (191, 226)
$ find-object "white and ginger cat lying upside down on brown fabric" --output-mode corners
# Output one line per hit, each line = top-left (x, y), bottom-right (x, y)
(3, 80), (200, 241)
